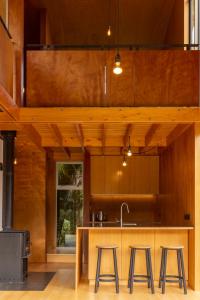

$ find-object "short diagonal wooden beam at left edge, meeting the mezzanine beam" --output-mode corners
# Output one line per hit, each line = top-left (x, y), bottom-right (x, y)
(0, 84), (20, 120)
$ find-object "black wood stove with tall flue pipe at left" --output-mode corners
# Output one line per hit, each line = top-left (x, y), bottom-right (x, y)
(0, 131), (30, 283)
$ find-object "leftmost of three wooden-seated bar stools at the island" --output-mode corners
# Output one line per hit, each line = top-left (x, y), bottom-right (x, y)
(94, 245), (119, 294)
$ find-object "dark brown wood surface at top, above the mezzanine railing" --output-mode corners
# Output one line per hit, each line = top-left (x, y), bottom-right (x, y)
(26, 0), (178, 45)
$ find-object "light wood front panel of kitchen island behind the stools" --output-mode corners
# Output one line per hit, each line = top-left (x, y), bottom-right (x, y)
(86, 227), (189, 283)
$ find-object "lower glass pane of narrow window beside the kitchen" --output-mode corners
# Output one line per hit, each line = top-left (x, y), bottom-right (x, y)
(57, 190), (83, 247)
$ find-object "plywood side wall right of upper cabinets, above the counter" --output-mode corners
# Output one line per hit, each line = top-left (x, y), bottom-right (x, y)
(159, 126), (195, 225)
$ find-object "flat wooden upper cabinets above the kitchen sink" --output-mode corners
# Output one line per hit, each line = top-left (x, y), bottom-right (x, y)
(91, 156), (159, 194)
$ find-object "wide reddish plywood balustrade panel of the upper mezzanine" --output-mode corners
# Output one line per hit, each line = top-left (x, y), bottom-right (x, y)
(27, 50), (199, 107)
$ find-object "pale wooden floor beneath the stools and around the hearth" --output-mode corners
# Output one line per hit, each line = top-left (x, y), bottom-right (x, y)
(0, 263), (200, 300)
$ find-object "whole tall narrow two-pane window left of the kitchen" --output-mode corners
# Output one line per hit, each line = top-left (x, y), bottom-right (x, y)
(56, 162), (83, 250)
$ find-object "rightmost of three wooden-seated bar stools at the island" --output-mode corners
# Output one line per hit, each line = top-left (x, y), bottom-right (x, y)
(159, 246), (187, 294)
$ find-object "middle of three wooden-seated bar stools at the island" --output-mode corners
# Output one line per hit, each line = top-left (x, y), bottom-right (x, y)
(128, 246), (155, 294)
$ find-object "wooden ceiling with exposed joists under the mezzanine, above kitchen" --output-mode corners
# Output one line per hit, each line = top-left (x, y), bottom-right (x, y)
(0, 117), (191, 157)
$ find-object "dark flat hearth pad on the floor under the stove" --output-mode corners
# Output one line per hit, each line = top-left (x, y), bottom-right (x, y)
(0, 272), (55, 291)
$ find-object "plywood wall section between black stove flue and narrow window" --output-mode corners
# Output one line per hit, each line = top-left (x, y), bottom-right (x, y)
(14, 137), (46, 262)
